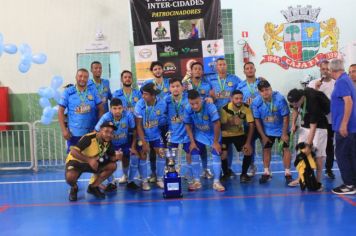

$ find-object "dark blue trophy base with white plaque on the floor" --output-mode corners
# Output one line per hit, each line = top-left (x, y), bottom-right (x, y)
(163, 172), (183, 198)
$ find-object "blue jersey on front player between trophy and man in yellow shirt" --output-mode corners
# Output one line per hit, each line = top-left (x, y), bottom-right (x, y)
(184, 101), (221, 145)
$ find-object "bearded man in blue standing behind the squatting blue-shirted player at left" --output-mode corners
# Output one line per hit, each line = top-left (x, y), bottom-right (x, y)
(112, 70), (142, 184)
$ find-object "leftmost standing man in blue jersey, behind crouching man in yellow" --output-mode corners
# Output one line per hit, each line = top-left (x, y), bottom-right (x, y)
(58, 68), (104, 153)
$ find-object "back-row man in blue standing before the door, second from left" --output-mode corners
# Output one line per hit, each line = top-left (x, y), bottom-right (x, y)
(88, 61), (111, 112)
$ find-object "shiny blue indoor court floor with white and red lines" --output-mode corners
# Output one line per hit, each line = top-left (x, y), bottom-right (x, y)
(0, 169), (356, 236)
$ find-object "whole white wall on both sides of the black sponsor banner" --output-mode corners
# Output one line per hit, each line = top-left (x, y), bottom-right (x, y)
(0, 0), (356, 96)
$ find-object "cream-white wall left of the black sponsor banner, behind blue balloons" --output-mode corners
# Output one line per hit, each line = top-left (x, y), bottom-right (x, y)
(0, 0), (131, 93)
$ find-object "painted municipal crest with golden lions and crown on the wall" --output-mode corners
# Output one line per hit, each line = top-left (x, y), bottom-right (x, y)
(261, 5), (339, 69)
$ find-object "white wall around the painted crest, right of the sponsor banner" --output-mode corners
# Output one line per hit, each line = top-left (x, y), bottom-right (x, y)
(221, 0), (356, 94)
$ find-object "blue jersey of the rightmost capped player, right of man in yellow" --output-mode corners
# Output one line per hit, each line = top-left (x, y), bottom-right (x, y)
(251, 91), (289, 137)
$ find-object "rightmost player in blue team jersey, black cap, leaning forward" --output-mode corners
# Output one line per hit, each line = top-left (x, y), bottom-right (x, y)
(251, 80), (293, 184)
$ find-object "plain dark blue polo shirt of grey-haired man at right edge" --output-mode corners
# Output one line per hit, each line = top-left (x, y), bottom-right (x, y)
(330, 73), (356, 133)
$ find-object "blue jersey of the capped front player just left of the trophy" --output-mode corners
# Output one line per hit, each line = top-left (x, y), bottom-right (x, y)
(135, 97), (167, 141)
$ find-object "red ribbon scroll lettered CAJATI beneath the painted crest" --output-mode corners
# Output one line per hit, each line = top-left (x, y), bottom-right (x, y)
(260, 52), (339, 70)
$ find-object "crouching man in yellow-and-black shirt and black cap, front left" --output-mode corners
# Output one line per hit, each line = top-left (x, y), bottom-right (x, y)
(65, 122), (120, 201)
